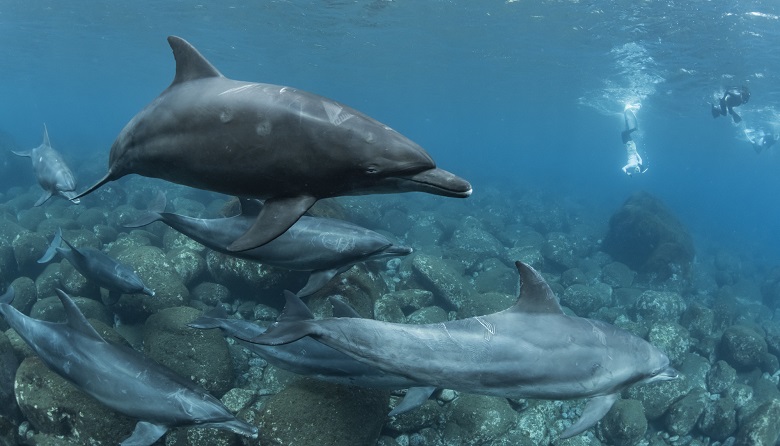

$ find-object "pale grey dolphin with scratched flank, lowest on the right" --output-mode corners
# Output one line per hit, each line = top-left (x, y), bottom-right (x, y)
(251, 262), (677, 438)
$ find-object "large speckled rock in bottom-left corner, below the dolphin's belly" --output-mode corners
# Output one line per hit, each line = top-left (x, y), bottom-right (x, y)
(15, 357), (136, 446)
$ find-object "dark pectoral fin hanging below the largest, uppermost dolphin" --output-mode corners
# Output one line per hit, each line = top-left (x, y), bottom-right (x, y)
(228, 196), (317, 251)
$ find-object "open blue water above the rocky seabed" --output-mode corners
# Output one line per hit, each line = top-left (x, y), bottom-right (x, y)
(0, 0), (780, 265)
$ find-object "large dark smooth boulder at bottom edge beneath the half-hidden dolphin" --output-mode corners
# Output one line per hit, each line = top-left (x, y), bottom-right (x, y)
(259, 379), (389, 446)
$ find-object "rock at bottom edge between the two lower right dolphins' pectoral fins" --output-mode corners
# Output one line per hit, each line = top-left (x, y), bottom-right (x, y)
(444, 394), (517, 446)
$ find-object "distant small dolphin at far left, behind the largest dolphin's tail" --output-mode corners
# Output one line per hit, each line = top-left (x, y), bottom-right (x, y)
(13, 124), (79, 206)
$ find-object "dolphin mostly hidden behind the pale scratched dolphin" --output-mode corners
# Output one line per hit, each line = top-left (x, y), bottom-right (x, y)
(189, 291), (436, 417)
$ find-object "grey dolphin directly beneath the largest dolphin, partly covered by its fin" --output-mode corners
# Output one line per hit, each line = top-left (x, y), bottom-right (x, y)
(124, 195), (412, 297)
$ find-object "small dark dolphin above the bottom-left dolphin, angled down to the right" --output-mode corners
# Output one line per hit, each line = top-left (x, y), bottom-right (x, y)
(38, 228), (154, 304)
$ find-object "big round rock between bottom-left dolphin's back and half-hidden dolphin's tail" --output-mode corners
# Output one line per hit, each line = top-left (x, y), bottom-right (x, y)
(144, 307), (233, 397)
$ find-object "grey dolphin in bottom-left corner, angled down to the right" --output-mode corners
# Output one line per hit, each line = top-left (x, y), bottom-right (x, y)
(0, 288), (258, 446)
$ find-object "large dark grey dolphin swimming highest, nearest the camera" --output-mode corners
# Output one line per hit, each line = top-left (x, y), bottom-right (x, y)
(78, 36), (471, 251)
